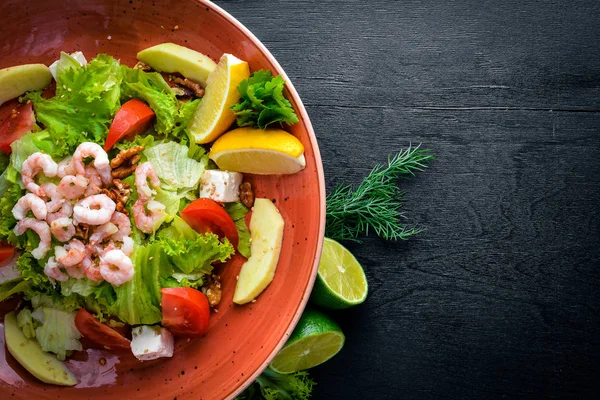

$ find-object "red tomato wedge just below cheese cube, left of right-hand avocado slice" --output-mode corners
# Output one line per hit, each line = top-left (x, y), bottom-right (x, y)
(181, 198), (238, 249)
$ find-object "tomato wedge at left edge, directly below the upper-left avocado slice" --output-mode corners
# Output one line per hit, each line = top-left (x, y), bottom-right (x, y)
(0, 100), (35, 154)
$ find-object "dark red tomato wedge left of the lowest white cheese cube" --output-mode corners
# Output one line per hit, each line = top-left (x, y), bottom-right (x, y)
(75, 308), (131, 350)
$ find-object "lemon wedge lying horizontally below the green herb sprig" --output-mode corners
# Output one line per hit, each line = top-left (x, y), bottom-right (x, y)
(209, 128), (306, 175)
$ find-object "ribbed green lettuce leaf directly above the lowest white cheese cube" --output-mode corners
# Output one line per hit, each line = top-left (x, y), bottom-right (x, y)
(110, 242), (173, 325)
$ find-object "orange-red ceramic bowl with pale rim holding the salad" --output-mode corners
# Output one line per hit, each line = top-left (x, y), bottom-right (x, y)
(0, 0), (325, 400)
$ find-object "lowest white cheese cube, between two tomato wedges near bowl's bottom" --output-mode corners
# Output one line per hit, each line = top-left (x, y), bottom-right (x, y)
(131, 325), (174, 361)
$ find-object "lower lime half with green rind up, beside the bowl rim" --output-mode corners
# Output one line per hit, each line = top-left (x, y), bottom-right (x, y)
(271, 309), (345, 374)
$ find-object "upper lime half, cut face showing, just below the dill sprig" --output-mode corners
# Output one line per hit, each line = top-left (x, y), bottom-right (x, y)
(311, 238), (369, 310)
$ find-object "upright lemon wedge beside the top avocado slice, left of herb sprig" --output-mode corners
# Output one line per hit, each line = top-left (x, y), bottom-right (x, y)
(189, 54), (250, 143)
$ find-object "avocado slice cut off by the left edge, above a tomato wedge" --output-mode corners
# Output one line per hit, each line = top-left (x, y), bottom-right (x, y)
(0, 64), (52, 104)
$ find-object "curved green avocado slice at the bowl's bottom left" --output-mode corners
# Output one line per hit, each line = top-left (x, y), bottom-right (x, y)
(4, 312), (77, 386)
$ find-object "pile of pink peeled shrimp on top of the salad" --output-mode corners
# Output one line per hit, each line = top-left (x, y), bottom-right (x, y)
(12, 142), (165, 286)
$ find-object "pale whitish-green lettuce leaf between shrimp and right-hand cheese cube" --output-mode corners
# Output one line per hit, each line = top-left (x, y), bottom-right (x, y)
(144, 141), (206, 195)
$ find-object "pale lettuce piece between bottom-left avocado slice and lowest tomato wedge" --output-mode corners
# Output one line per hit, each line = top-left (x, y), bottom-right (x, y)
(31, 307), (83, 360)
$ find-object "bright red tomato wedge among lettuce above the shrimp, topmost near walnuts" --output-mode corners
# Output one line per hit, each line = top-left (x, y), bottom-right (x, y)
(104, 99), (154, 151)
